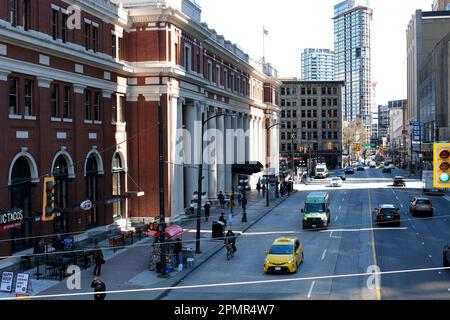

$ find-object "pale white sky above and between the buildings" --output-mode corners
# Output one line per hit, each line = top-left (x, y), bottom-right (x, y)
(196, 0), (433, 104)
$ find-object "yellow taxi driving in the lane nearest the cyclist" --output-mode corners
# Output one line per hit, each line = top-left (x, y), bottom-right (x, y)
(264, 238), (303, 273)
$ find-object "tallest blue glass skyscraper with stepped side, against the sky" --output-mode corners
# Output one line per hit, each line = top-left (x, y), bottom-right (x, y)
(333, 0), (372, 127)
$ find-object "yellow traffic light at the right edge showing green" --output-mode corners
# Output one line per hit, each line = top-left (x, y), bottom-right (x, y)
(433, 143), (450, 189)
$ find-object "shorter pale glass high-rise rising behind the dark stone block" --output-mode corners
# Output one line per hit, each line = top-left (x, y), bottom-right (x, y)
(302, 48), (334, 81)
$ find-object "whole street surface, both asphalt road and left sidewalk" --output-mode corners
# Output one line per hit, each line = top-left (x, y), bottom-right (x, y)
(11, 169), (450, 300)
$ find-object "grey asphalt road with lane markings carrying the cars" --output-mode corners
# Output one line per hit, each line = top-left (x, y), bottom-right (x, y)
(165, 169), (450, 300)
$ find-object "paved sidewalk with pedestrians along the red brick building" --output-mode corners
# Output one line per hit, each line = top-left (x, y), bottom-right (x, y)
(7, 191), (296, 300)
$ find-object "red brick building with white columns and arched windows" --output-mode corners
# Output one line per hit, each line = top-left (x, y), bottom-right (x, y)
(0, 0), (281, 255)
